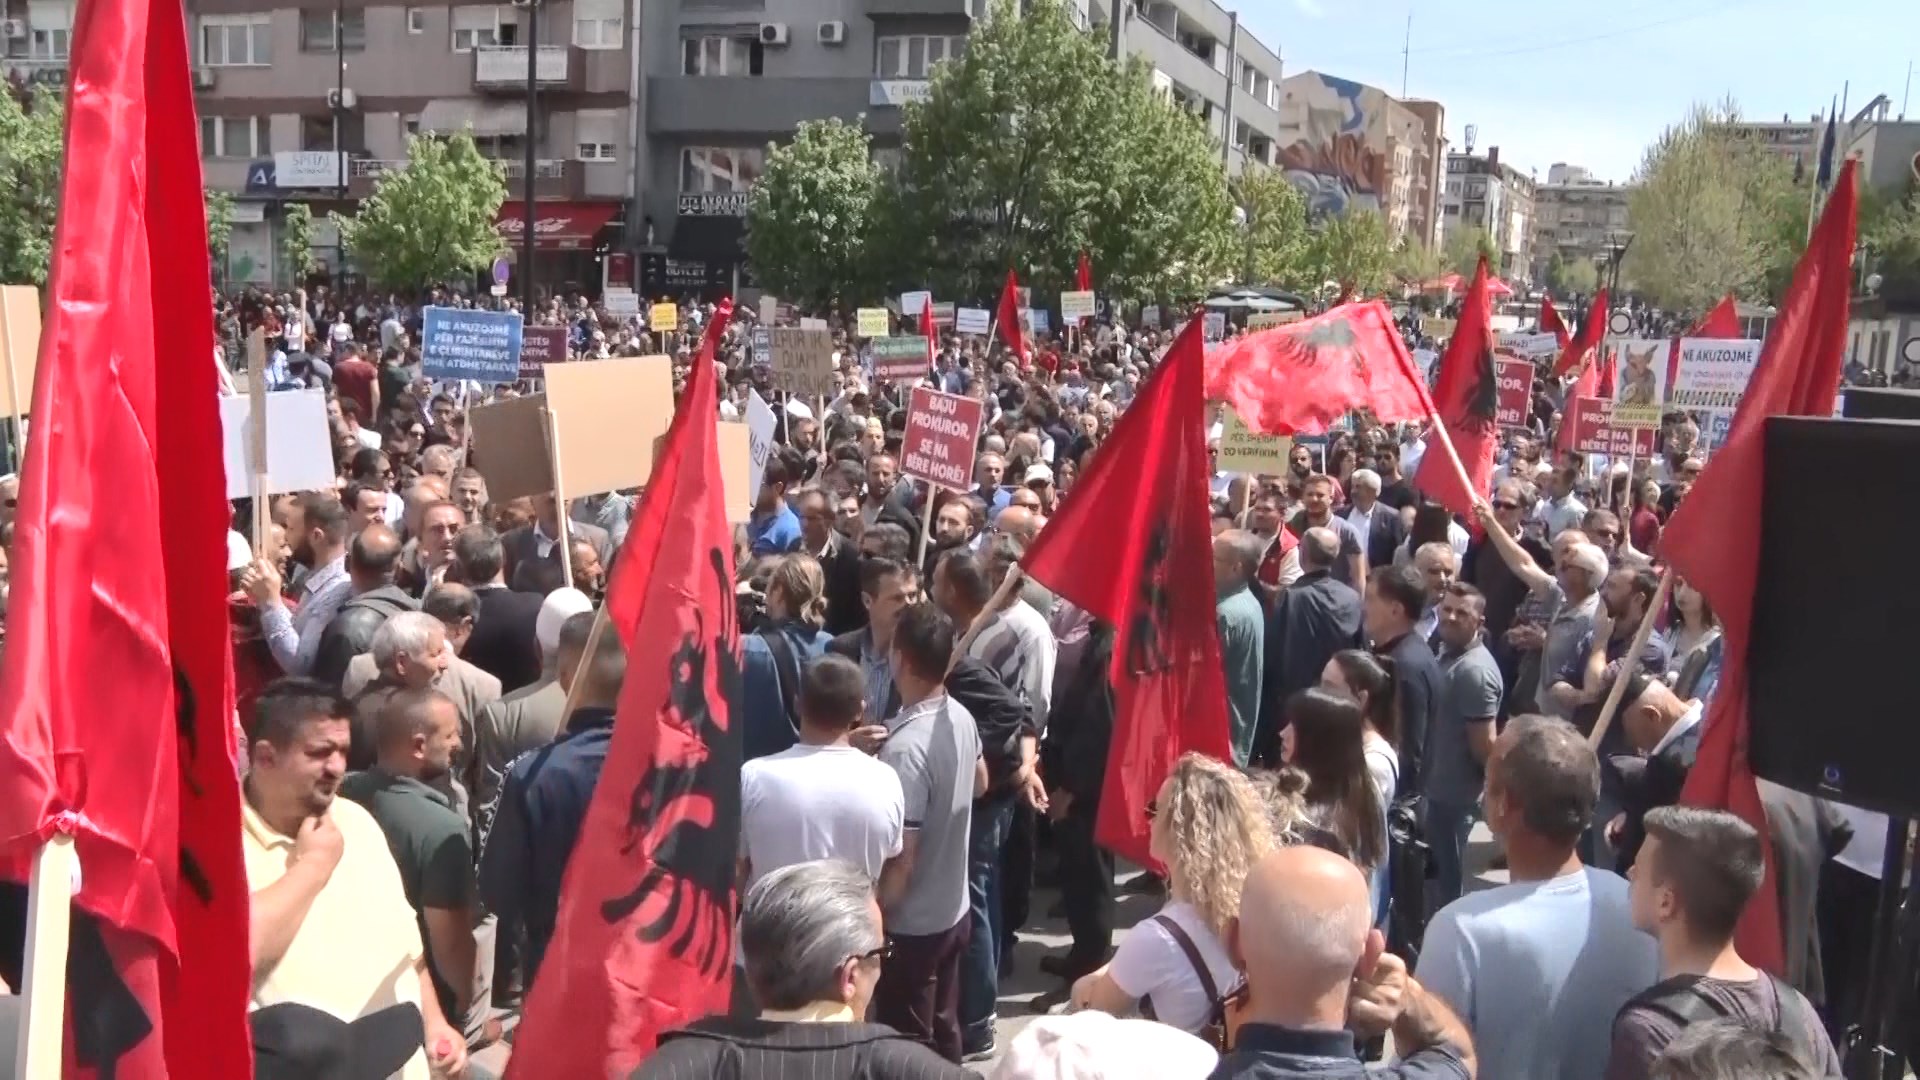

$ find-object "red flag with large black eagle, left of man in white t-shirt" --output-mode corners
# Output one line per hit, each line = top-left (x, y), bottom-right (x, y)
(507, 300), (741, 1080)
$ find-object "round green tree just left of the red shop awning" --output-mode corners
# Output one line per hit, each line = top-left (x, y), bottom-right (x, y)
(332, 133), (507, 290)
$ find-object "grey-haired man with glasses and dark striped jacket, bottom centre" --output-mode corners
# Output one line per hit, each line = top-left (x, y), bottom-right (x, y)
(634, 859), (973, 1080)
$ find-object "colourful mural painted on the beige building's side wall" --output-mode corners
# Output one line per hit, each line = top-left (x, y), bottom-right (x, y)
(1279, 71), (1388, 217)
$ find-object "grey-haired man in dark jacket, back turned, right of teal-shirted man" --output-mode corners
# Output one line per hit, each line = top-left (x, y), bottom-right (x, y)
(1254, 528), (1361, 765)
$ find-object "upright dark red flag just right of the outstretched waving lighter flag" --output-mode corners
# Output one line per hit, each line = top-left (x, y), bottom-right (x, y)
(1413, 256), (1500, 517)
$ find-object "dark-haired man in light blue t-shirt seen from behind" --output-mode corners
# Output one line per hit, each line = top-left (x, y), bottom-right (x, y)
(1419, 717), (1659, 1080)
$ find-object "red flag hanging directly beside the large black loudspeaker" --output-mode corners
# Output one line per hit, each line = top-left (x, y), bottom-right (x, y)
(1661, 160), (1859, 974)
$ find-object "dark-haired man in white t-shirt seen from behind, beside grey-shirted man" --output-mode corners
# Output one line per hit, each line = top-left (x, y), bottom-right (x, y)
(739, 655), (906, 888)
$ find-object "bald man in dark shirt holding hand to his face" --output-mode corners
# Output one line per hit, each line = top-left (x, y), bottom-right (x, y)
(1212, 847), (1475, 1080)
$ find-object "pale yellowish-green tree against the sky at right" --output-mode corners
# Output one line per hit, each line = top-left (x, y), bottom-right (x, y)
(1620, 102), (1807, 311)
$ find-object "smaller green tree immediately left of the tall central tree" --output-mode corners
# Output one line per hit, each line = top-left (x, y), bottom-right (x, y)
(747, 117), (881, 307)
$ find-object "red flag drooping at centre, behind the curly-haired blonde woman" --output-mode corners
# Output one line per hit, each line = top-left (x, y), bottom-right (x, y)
(1020, 317), (1233, 865)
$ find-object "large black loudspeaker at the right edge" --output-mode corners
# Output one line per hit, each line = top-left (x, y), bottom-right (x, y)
(1747, 417), (1920, 817)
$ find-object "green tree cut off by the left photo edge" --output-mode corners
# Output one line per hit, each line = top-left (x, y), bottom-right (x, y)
(0, 85), (65, 284)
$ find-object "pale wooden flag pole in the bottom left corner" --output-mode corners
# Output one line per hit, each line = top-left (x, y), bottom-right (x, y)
(13, 832), (81, 1080)
